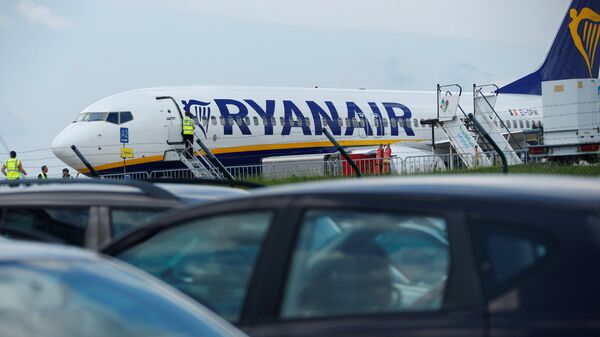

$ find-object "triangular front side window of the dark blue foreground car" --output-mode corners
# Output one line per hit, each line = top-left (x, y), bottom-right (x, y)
(117, 211), (272, 322)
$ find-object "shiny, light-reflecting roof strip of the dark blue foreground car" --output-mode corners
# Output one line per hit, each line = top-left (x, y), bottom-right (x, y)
(244, 175), (600, 206)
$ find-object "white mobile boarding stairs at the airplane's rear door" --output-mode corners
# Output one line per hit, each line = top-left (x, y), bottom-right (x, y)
(437, 84), (522, 168)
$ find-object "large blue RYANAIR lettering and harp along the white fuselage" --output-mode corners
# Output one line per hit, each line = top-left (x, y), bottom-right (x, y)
(181, 99), (415, 138)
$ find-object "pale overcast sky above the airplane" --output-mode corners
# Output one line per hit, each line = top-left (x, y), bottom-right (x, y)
(0, 0), (570, 175)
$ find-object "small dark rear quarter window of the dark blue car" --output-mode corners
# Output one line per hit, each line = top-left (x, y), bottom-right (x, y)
(471, 223), (551, 297)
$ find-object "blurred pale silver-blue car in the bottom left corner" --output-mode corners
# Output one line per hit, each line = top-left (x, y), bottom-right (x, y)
(0, 241), (244, 337)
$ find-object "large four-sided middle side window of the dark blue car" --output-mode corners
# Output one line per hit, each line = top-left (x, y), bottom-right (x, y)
(281, 210), (450, 318)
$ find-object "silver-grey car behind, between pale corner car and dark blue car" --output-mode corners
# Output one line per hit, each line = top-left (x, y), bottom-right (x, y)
(0, 179), (248, 250)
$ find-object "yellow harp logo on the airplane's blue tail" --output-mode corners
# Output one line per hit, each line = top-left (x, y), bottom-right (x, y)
(569, 7), (600, 77)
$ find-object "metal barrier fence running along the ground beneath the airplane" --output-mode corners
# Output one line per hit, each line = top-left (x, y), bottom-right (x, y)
(91, 150), (600, 180)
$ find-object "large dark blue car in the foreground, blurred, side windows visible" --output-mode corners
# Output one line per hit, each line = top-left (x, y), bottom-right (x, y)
(104, 176), (600, 337)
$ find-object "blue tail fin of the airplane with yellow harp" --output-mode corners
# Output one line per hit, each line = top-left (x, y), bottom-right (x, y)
(498, 0), (600, 95)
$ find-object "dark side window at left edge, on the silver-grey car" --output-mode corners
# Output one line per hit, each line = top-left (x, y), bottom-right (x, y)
(3, 207), (90, 246)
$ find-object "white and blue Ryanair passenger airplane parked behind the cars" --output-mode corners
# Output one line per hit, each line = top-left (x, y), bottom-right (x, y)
(52, 0), (600, 174)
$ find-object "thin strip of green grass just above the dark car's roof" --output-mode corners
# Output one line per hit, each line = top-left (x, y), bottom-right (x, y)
(247, 163), (600, 185)
